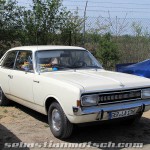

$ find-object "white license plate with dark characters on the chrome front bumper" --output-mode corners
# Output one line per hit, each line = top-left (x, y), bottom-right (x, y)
(109, 109), (136, 119)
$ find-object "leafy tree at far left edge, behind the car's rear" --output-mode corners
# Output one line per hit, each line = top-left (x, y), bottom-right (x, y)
(0, 0), (23, 57)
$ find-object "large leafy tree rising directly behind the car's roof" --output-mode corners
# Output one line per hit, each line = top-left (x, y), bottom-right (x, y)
(22, 0), (83, 45)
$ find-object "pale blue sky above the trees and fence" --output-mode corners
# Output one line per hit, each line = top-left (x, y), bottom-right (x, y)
(18, 0), (150, 34)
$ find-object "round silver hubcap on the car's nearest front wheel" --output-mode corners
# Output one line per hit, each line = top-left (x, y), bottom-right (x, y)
(52, 109), (61, 131)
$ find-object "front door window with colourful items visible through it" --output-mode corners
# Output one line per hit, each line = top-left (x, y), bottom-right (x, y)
(15, 51), (33, 72)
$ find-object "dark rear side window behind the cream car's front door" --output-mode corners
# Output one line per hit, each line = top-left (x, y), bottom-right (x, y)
(2, 51), (17, 69)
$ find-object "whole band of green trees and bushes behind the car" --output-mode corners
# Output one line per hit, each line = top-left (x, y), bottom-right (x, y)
(0, 0), (150, 69)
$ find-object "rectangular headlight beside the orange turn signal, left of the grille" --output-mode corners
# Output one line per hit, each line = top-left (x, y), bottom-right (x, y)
(81, 94), (99, 106)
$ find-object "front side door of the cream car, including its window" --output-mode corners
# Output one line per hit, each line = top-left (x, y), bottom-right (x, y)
(10, 50), (34, 102)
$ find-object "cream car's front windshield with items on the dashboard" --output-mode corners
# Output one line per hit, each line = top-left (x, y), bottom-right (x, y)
(36, 50), (102, 72)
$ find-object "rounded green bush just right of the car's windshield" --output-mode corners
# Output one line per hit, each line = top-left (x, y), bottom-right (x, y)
(96, 33), (119, 69)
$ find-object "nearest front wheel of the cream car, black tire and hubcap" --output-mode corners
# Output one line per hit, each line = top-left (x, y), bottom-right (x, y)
(48, 102), (73, 139)
